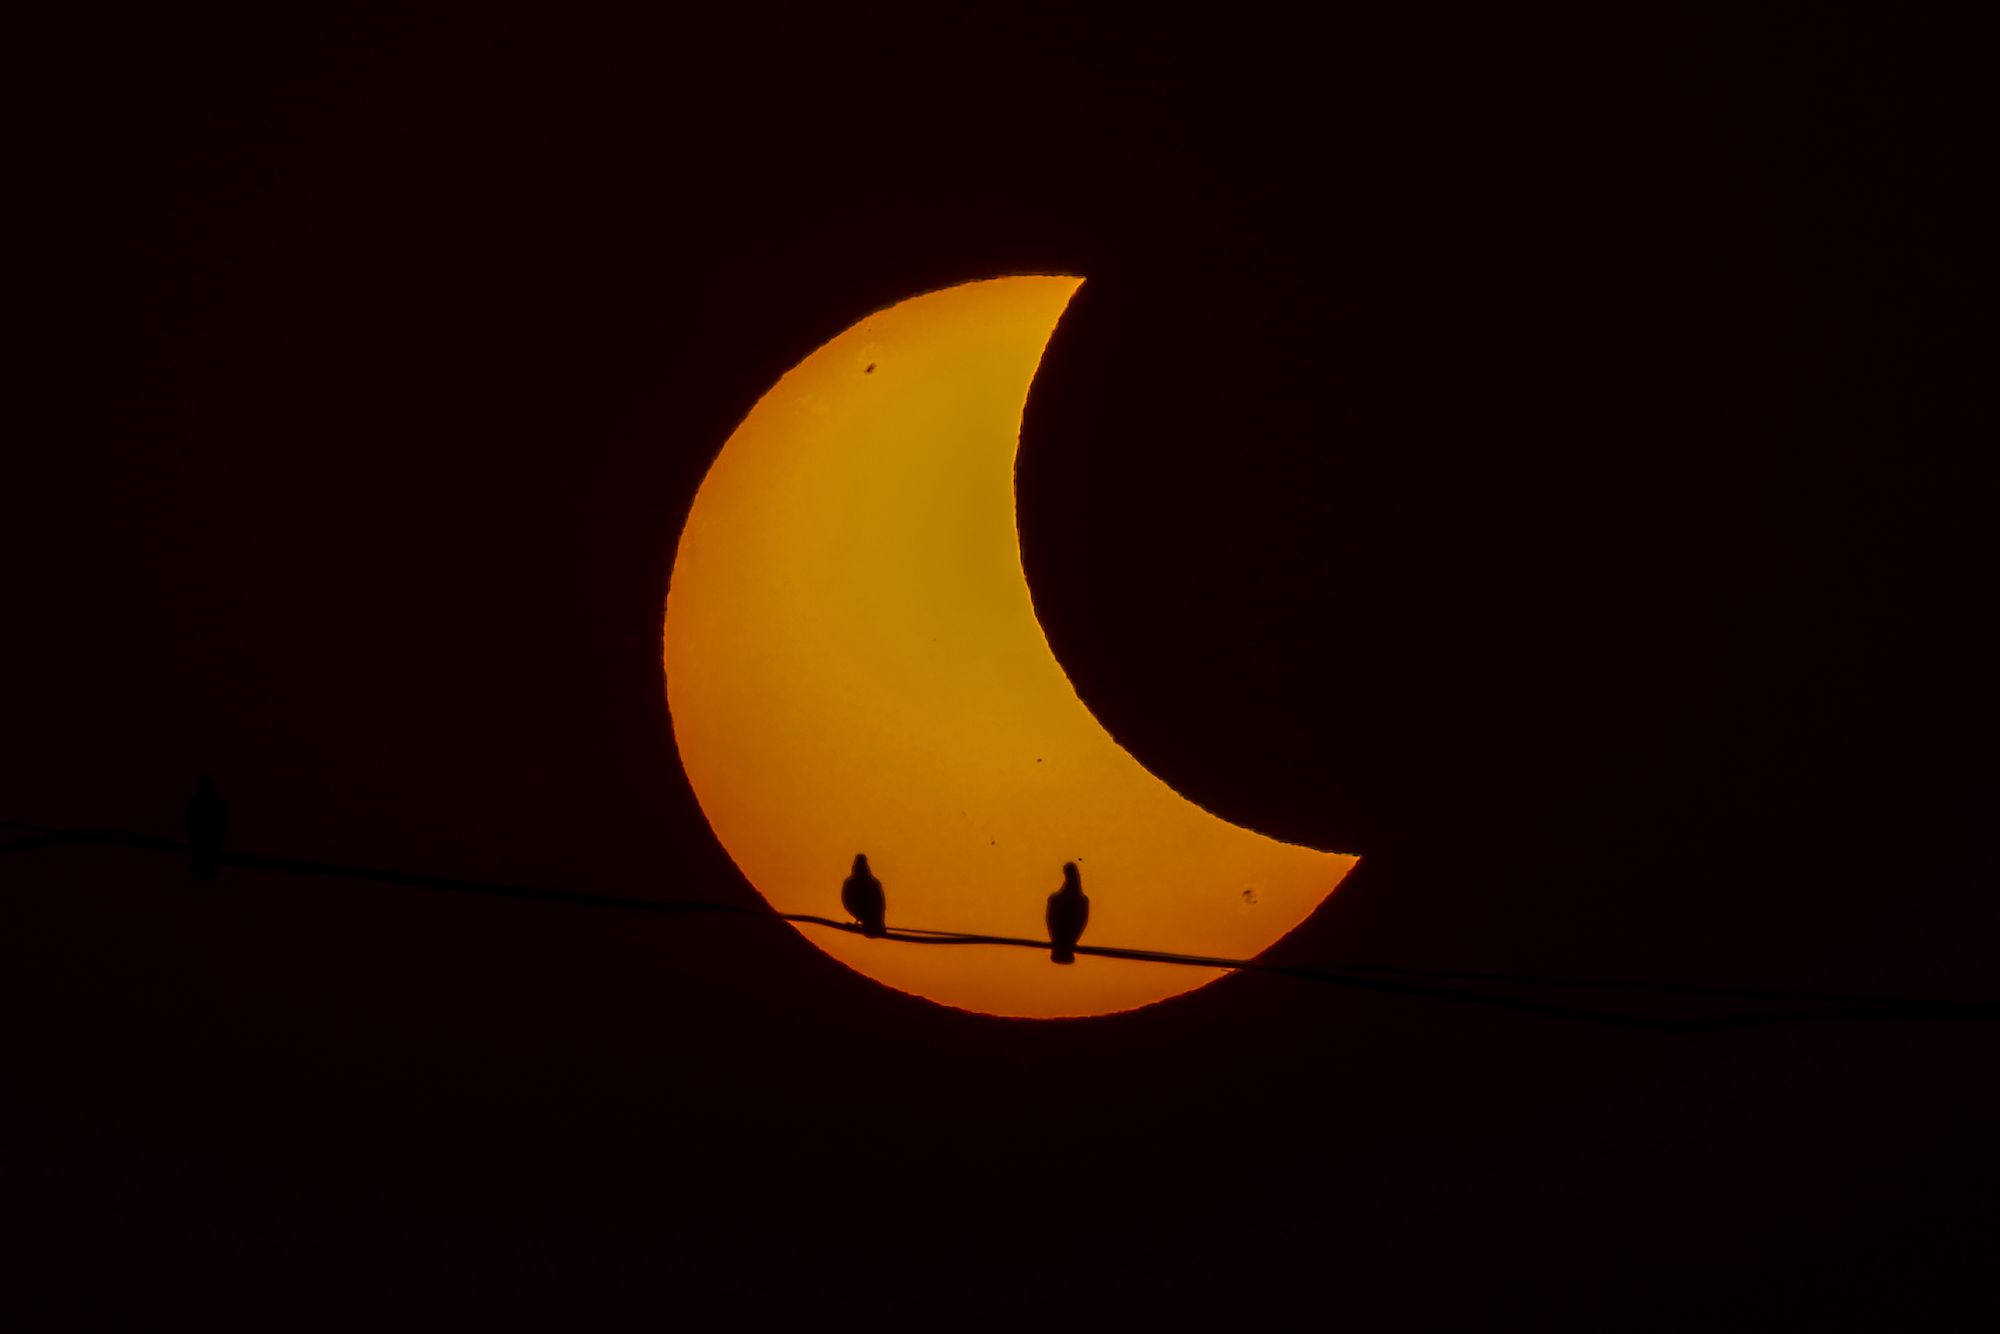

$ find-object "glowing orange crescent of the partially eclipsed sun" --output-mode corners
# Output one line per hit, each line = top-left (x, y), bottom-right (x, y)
(666, 276), (1356, 1018)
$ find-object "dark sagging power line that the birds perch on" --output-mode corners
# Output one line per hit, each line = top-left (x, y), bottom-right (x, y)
(0, 820), (2000, 1032)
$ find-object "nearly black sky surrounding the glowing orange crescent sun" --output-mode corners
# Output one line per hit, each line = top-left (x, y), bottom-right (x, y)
(0, 6), (2000, 1328)
